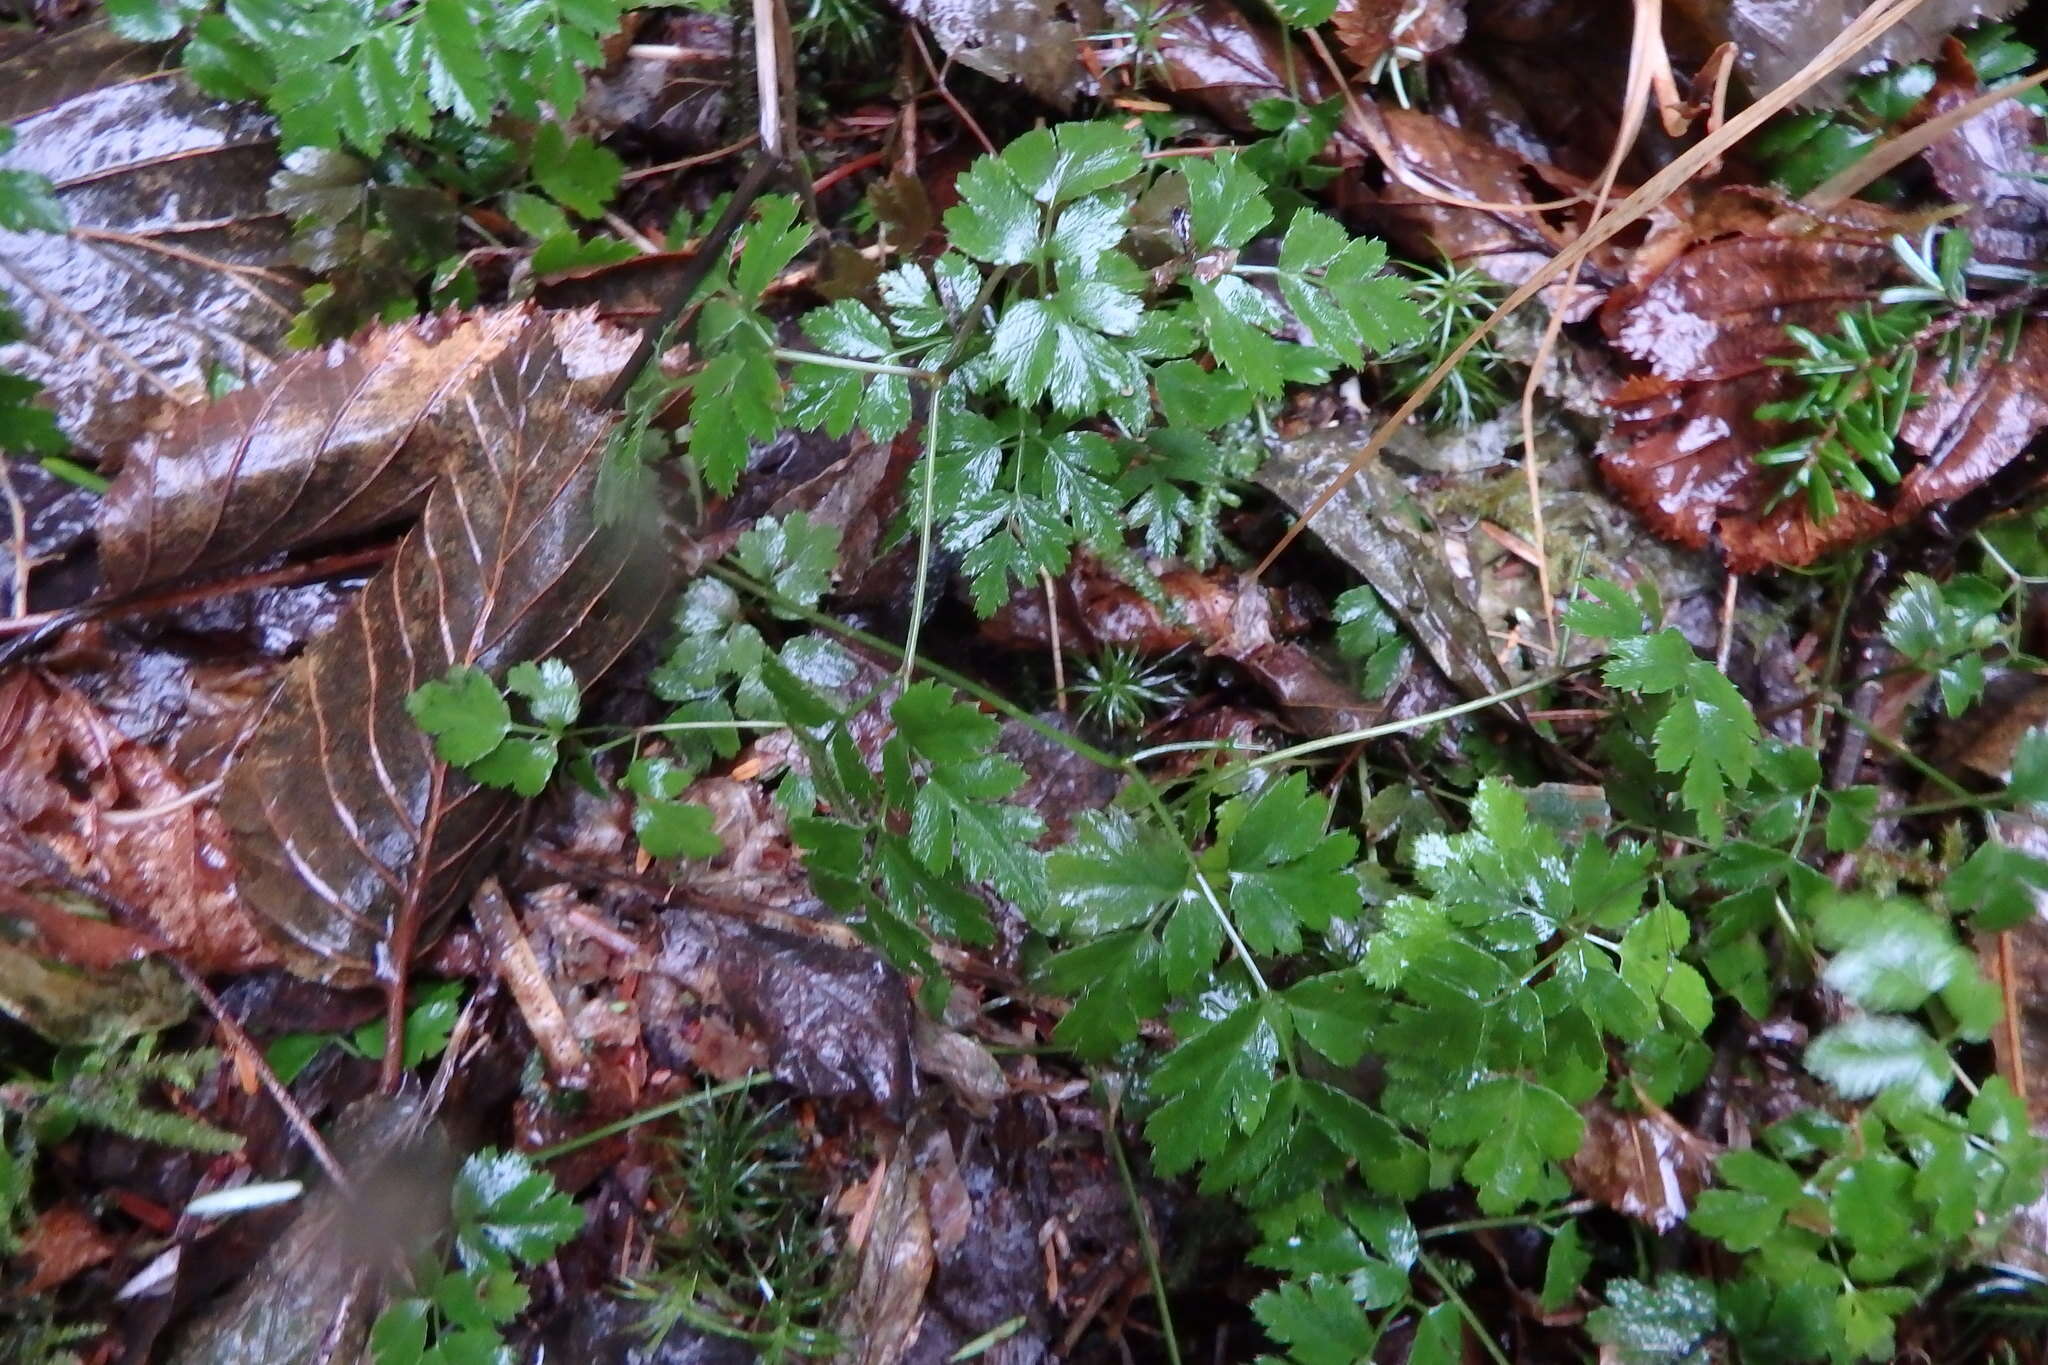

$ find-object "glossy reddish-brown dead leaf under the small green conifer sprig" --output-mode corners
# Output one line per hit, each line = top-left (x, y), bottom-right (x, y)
(1602, 190), (2048, 573)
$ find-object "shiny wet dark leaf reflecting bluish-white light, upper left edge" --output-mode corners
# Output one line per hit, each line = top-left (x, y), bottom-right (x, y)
(0, 25), (301, 450)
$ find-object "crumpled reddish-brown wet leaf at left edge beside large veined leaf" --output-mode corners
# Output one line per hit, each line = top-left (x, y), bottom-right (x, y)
(0, 669), (276, 972)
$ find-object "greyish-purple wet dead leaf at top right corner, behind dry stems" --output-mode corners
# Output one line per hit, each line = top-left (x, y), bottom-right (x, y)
(1720, 0), (2019, 108)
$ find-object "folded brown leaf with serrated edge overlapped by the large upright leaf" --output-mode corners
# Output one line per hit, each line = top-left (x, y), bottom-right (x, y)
(100, 311), (528, 593)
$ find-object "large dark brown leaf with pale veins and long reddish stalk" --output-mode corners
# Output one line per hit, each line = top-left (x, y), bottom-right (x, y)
(221, 309), (670, 984)
